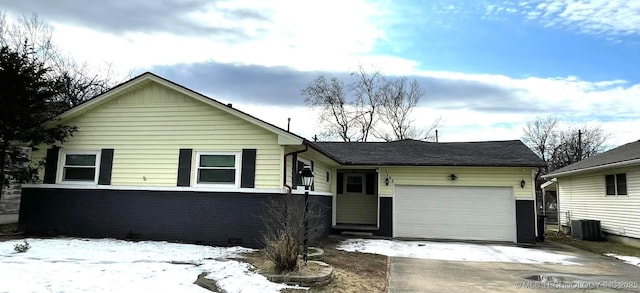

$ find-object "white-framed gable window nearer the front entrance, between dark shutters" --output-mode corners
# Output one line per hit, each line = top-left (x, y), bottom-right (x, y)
(196, 153), (240, 186)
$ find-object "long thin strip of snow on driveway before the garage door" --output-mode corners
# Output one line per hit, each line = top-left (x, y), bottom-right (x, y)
(338, 239), (578, 265)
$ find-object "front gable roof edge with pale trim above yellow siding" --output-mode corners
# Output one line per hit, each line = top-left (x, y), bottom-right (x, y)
(49, 72), (308, 145)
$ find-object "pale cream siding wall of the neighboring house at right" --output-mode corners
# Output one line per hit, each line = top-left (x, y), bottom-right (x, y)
(558, 166), (640, 238)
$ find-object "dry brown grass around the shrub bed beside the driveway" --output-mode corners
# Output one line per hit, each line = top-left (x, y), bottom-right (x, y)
(237, 238), (389, 293)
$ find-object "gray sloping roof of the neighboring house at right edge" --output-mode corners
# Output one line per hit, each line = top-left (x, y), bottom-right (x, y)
(542, 140), (640, 178)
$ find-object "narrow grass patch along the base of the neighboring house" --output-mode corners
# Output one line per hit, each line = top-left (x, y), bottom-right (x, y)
(545, 233), (640, 257)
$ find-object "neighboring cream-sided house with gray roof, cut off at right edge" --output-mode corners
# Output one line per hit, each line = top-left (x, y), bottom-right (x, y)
(543, 141), (640, 243)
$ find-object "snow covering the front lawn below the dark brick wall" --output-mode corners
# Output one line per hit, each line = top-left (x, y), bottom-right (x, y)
(0, 238), (296, 293)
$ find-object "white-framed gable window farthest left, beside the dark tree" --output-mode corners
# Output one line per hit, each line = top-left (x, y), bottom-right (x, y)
(62, 152), (98, 183)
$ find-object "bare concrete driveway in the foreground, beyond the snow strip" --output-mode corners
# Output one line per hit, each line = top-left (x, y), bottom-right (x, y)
(389, 242), (640, 293)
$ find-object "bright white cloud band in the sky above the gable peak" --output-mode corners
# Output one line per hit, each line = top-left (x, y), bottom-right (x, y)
(17, 0), (402, 76)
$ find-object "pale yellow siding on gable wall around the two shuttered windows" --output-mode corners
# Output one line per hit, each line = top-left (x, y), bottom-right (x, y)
(34, 83), (284, 188)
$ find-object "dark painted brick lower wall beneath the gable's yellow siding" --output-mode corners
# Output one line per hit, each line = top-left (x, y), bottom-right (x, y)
(19, 188), (332, 247)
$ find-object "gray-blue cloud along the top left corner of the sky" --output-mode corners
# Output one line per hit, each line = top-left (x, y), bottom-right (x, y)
(4, 0), (268, 38)
